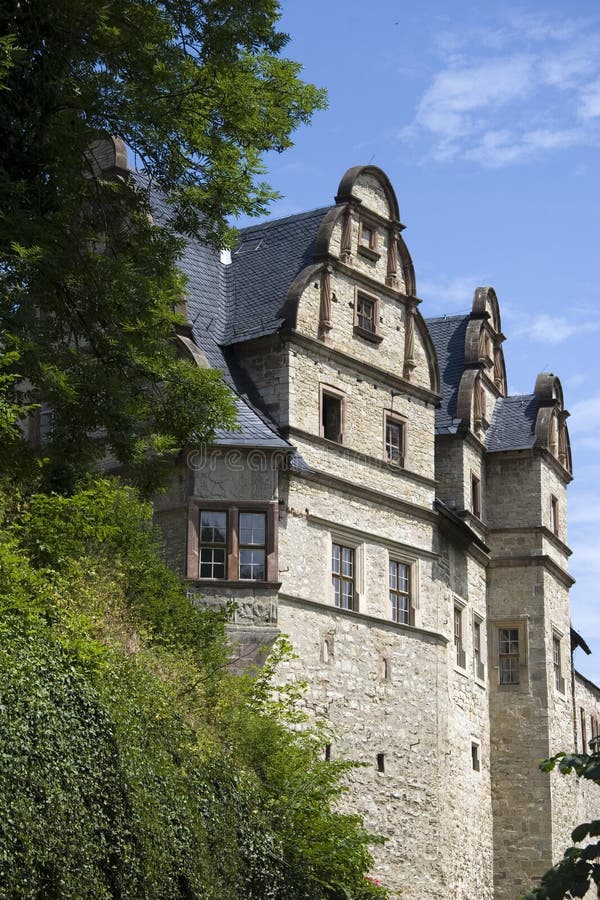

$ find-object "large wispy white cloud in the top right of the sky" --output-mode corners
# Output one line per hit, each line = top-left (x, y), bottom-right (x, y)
(402, 12), (600, 167)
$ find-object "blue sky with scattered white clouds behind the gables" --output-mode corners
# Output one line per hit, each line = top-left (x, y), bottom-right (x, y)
(244, 0), (600, 684)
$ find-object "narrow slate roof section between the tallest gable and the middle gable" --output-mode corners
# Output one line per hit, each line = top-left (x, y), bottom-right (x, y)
(425, 315), (469, 434)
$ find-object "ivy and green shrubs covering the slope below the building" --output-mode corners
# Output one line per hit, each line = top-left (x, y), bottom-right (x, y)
(0, 481), (386, 900)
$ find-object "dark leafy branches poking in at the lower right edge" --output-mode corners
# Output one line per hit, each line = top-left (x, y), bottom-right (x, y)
(523, 743), (600, 900)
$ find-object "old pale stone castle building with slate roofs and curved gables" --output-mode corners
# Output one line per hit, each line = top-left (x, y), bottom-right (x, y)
(157, 166), (600, 900)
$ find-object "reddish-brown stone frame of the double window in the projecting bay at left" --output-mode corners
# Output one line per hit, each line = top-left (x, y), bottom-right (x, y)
(186, 499), (279, 588)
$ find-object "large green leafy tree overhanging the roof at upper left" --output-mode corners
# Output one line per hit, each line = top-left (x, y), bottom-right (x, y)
(0, 0), (324, 488)
